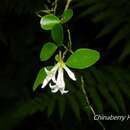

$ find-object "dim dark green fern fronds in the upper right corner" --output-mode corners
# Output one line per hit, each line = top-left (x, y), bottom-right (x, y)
(76, 0), (130, 61)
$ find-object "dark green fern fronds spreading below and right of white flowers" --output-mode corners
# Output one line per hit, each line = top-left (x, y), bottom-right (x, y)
(0, 67), (130, 130)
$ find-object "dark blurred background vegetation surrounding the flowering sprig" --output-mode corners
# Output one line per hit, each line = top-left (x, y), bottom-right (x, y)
(0, 0), (130, 130)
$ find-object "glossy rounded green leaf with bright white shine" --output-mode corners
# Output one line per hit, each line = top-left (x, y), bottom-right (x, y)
(40, 14), (60, 30)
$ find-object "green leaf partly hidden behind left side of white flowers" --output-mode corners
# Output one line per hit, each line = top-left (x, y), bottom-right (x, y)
(33, 68), (46, 91)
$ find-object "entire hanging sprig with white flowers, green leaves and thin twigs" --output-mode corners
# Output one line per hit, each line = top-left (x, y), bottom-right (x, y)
(33, 0), (105, 130)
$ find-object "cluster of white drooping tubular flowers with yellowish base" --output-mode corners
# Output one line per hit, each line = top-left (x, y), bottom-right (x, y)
(42, 61), (76, 94)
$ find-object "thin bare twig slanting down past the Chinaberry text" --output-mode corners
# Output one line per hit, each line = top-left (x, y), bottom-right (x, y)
(81, 76), (105, 130)
